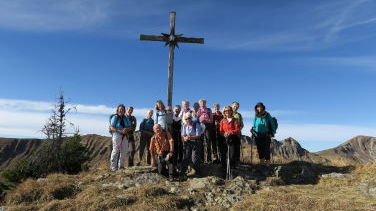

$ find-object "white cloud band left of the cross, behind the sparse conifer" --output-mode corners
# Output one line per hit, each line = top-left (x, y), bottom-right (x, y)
(0, 99), (153, 138)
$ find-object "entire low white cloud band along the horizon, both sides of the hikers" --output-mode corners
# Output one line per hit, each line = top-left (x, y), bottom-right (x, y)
(0, 99), (376, 152)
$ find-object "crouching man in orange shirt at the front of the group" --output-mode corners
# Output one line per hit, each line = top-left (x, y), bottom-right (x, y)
(150, 124), (174, 180)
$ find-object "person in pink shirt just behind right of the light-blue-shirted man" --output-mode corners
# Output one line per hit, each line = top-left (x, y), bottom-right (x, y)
(197, 99), (218, 162)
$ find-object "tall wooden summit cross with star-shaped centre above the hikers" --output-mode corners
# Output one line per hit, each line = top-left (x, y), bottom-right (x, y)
(140, 12), (204, 106)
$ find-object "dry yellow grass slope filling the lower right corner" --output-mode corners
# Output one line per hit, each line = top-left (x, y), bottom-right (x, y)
(232, 164), (376, 211)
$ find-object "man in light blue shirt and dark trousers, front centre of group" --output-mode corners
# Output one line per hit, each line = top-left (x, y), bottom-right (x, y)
(181, 114), (202, 177)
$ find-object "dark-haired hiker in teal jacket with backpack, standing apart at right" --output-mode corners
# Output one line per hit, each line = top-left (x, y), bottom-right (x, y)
(251, 102), (277, 165)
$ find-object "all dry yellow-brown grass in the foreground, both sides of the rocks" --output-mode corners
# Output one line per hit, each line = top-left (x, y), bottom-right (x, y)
(6, 164), (376, 211)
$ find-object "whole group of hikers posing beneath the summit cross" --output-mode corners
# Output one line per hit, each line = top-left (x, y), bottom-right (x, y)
(110, 99), (278, 180)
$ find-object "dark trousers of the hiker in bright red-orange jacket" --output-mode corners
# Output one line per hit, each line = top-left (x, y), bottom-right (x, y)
(221, 135), (240, 169)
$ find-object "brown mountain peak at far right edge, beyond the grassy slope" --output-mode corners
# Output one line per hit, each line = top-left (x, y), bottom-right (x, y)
(317, 136), (376, 164)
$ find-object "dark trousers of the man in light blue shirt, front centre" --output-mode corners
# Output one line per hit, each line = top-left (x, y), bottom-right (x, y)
(181, 139), (202, 174)
